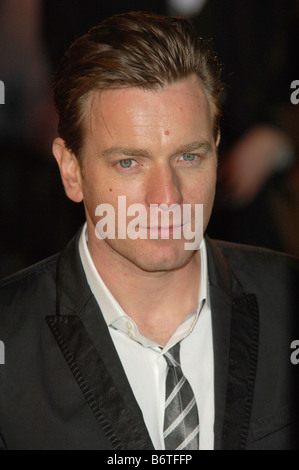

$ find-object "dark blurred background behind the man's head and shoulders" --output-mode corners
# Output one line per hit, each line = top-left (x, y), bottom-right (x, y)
(0, 0), (299, 277)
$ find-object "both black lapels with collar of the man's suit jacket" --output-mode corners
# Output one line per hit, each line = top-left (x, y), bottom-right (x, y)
(47, 230), (258, 450)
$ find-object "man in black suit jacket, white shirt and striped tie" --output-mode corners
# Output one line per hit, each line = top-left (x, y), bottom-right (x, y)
(0, 13), (298, 451)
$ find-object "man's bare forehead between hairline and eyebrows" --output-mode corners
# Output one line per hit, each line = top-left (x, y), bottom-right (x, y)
(86, 76), (212, 145)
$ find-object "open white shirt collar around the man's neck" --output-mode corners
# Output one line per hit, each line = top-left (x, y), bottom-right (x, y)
(79, 223), (208, 352)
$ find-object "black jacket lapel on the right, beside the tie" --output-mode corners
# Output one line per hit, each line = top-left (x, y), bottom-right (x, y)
(207, 239), (259, 449)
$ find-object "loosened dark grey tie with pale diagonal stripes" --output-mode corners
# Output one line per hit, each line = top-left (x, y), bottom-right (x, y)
(163, 343), (199, 450)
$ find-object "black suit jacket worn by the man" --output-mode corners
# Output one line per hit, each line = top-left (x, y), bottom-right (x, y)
(0, 234), (299, 450)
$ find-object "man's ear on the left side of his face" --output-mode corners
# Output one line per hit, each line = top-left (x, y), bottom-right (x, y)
(52, 137), (83, 202)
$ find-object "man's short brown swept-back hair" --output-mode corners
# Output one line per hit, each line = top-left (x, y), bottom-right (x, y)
(53, 12), (222, 161)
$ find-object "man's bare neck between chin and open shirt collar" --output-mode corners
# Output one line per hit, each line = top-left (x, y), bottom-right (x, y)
(89, 226), (201, 345)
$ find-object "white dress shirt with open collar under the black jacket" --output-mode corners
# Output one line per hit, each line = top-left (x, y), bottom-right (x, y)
(79, 224), (214, 450)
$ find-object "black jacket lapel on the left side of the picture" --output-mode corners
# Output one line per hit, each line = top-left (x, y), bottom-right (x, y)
(46, 231), (153, 450)
